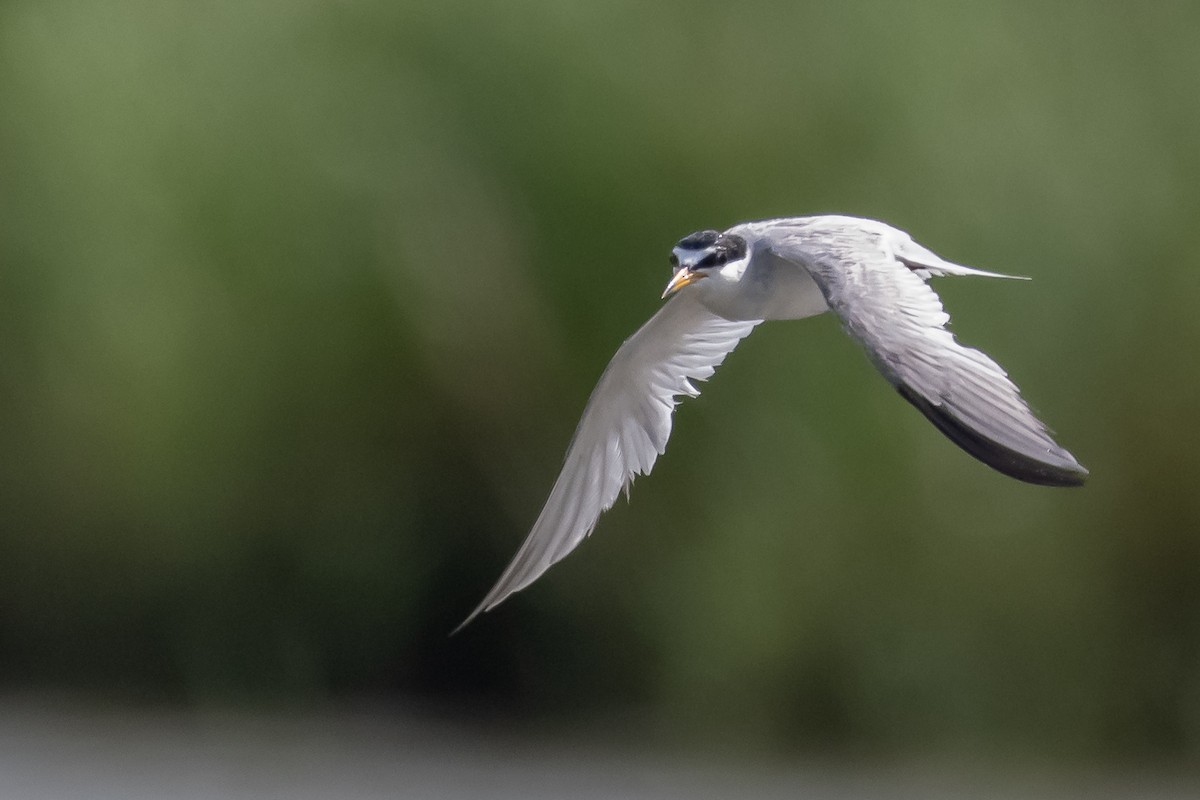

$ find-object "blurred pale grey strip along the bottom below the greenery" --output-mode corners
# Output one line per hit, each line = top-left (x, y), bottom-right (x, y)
(0, 698), (1198, 800)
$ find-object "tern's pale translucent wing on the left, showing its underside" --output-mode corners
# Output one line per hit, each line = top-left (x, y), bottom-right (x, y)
(458, 291), (758, 628)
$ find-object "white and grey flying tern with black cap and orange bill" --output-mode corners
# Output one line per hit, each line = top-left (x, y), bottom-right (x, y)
(456, 216), (1087, 630)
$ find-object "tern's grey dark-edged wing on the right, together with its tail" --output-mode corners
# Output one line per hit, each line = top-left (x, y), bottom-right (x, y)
(767, 223), (1087, 486)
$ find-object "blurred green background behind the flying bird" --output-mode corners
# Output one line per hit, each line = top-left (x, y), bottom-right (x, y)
(0, 0), (1200, 763)
